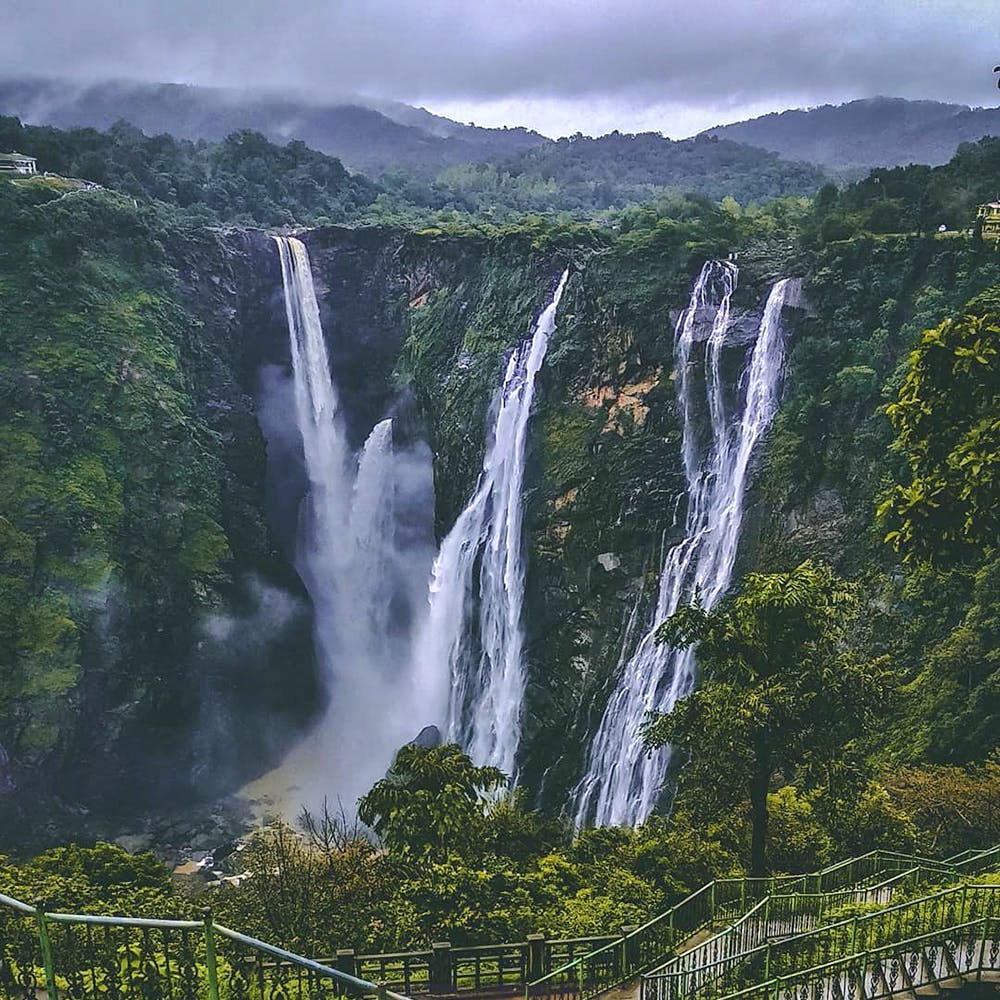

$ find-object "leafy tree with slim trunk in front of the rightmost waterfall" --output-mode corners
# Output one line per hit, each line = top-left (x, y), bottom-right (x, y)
(644, 561), (888, 875)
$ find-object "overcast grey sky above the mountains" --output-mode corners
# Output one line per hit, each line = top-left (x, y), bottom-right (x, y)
(0, 0), (1000, 137)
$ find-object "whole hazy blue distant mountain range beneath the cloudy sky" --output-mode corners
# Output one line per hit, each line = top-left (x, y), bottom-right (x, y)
(0, 78), (1000, 204)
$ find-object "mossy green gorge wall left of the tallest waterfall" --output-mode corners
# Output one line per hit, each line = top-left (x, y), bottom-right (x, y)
(0, 207), (330, 845)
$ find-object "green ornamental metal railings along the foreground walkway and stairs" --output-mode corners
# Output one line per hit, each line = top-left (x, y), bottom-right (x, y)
(0, 847), (1000, 1000)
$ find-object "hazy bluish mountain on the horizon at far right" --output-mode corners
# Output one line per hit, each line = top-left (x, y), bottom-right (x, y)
(705, 97), (1000, 171)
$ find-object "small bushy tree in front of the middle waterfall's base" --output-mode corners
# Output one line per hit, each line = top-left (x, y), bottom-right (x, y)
(358, 743), (507, 854)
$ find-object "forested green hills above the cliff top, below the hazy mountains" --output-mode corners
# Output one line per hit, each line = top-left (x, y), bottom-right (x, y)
(0, 117), (825, 226)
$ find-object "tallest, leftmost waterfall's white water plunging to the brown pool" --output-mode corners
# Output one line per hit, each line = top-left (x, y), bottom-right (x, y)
(250, 236), (429, 812)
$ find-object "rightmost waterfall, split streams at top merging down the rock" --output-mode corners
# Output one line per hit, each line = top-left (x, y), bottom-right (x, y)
(576, 261), (799, 826)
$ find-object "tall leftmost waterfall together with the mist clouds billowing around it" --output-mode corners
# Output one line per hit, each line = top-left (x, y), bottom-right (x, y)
(246, 237), (434, 816)
